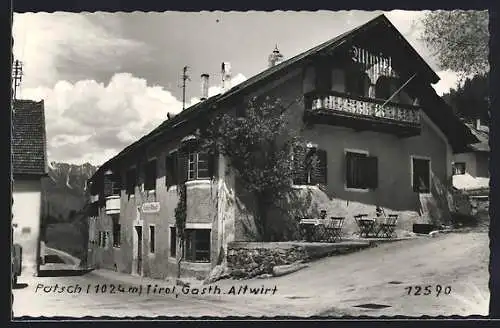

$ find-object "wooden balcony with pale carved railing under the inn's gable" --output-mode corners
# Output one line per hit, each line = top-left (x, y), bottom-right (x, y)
(304, 91), (421, 137)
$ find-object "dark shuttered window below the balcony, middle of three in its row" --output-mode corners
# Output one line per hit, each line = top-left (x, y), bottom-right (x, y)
(345, 151), (378, 189)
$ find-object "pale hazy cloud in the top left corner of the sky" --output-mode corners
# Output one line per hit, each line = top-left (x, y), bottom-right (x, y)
(12, 12), (149, 88)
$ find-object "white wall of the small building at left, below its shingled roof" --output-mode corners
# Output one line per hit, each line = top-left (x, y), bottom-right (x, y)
(12, 180), (42, 274)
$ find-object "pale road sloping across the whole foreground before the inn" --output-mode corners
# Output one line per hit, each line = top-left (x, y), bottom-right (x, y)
(13, 233), (489, 317)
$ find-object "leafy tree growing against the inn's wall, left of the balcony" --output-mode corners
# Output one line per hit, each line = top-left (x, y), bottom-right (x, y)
(200, 98), (305, 241)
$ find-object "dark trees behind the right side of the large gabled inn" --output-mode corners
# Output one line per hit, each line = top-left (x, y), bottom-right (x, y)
(443, 74), (489, 123)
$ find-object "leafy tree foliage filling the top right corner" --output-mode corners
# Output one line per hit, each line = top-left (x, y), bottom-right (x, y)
(421, 10), (489, 77)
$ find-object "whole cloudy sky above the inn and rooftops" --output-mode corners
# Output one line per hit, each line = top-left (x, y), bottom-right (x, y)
(13, 10), (458, 165)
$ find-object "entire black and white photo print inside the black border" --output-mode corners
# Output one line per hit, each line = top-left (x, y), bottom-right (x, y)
(10, 10), (491, 321)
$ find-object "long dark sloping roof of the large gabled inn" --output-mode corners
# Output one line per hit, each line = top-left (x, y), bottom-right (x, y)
(96, 15), (472, 179)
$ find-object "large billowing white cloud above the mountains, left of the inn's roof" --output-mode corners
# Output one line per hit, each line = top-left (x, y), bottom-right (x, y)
(23, 73), (245, 165)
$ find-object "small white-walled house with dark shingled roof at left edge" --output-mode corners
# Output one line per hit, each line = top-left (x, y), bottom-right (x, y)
(11, 100), (48, 274)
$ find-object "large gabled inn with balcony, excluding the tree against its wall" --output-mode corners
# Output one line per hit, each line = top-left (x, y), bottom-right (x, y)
(89, 15), (477, 278)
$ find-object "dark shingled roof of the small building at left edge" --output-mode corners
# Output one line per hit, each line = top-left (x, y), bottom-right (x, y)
(11, 100), (47, 178)
